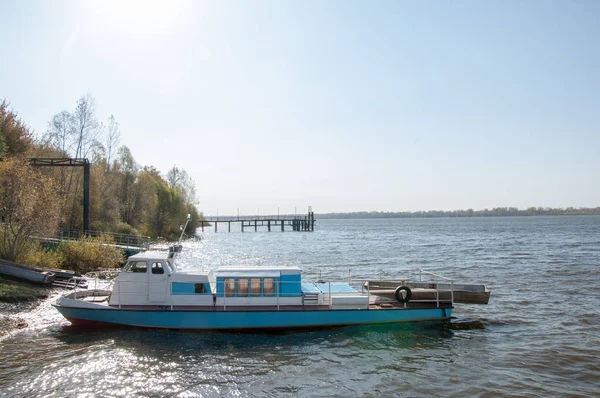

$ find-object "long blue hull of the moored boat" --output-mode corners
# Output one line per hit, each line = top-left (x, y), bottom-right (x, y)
(55, 305), (452, 330)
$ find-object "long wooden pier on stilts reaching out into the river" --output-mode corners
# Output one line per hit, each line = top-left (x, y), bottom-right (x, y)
(198, 211), (315, 232)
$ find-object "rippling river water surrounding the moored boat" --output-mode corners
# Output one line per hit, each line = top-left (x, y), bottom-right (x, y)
(0, 216), (600, 397)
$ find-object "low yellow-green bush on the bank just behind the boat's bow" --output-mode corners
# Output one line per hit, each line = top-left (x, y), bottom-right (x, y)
(58, 237), (123, 274)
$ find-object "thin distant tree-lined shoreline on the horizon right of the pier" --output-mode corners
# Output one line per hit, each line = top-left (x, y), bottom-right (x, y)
(315, 207), (600, 219)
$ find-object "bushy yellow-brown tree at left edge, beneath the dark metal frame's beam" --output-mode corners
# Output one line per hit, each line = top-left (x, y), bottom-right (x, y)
(0, 157), (62, 261)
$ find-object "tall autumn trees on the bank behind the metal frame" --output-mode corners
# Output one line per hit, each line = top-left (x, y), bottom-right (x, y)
(37, 94), (202, 237)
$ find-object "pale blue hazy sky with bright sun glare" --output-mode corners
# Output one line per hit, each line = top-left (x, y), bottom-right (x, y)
(0, 0), (600, 215)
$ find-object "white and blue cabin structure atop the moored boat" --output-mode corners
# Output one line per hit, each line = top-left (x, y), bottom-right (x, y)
(109, 252), (310, 307)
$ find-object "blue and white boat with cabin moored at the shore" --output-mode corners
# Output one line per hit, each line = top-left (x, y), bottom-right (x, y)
(53, 246), (489, 330)
